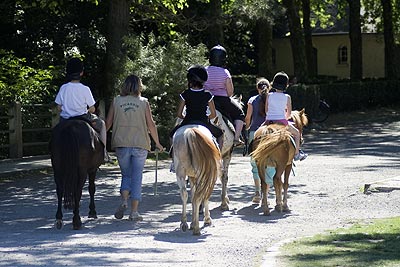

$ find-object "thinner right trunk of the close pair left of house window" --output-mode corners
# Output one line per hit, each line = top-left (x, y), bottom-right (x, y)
(302, 0), (317, 77)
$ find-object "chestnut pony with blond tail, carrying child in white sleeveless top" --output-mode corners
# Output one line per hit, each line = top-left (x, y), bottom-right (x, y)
(251, 109), (308, 215)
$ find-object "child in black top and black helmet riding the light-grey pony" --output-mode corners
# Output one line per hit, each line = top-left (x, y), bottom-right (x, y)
(170, 65), (223, 149)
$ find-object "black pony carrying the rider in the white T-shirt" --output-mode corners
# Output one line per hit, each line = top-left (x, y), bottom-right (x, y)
(50, 119), (104, 230)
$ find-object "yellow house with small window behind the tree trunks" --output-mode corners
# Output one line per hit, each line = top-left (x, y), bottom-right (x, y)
(272, 32), (385, 79)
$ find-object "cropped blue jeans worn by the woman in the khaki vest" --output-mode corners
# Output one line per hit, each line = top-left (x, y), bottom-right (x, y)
(115, 147), (148, 201)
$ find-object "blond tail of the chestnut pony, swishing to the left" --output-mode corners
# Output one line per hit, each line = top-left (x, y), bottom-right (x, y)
(250, 131), (291, 171)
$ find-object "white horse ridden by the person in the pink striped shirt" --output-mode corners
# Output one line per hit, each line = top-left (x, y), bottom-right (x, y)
(211, 96), (243, 211)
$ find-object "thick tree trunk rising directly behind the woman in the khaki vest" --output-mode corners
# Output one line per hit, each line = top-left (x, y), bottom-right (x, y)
(102, 0), (130, 107)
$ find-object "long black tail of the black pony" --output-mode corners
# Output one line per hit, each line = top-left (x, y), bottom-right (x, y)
(58, 129), (80, 210)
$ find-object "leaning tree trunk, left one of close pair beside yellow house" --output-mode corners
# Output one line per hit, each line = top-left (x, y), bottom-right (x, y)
(283, 0), (307, 82)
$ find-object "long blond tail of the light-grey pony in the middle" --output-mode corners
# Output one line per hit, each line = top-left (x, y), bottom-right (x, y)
(185, 128), (221, 201)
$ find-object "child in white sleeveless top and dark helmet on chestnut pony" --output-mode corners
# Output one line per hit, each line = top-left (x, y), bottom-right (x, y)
(265, 72), (308, 160)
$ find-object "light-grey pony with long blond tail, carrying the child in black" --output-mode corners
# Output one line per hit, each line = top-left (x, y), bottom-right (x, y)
(172, 124), (221, 235)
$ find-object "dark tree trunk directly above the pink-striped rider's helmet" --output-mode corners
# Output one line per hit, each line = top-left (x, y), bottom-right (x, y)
(207, 0), (224, 48)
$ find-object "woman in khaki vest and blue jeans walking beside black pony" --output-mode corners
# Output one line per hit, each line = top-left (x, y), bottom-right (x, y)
(106, 75), (164, 221)
